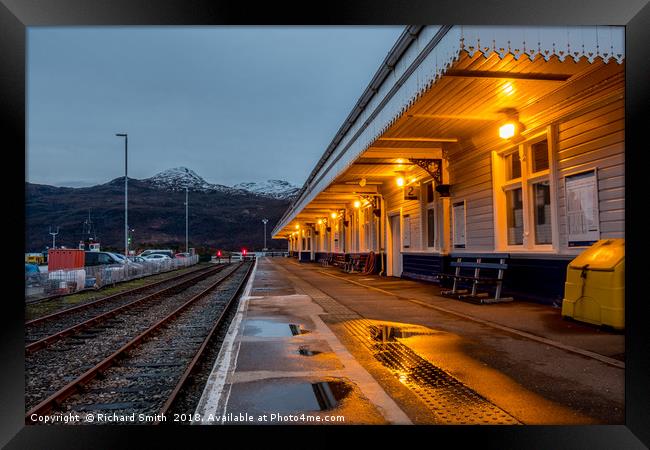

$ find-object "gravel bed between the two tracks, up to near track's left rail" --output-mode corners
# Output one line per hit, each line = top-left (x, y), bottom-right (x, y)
(25, 264), (249, 416)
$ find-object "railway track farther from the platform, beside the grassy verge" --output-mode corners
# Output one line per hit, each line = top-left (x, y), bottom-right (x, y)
(25, 265), (225, 353)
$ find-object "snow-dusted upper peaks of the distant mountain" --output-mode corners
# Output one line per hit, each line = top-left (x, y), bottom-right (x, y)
(142, 167), (299, 199)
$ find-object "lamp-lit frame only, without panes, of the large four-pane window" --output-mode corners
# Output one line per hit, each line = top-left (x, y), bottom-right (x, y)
(492, 127), (559, 253)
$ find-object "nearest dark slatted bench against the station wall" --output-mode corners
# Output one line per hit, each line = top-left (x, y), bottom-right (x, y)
(438, 253), (513, 304)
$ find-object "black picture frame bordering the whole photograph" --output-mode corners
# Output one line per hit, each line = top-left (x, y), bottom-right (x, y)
(0, 0), (650, 449)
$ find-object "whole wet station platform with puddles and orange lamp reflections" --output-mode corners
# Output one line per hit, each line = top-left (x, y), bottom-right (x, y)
(196, 258), (625, 425)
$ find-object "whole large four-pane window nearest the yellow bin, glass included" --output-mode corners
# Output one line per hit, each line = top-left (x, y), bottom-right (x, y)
(493, 133), (554, 250)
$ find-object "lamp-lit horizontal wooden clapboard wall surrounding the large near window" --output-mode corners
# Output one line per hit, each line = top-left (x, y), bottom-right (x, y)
(447, 60), (625, 253)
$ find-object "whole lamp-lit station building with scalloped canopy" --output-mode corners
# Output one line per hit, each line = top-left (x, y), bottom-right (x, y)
(273, 26), (625, 303)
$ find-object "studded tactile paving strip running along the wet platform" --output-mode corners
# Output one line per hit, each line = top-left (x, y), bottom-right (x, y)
(276, 262), (521, 425)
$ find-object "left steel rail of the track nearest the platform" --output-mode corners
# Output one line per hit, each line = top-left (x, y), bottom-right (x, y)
(25, 262), (243, 423)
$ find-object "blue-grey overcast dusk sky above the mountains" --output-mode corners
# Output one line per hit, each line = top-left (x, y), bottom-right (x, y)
(26, 26), (403, 187)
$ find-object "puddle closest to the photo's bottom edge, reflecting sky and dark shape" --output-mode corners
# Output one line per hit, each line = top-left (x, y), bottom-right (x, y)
(231, 381), (352, 414)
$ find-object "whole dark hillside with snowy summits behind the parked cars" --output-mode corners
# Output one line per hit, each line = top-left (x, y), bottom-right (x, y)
(25, 168), (297, 251)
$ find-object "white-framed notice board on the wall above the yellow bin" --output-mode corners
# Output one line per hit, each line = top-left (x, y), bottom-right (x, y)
(564, 170), (600, 247)
